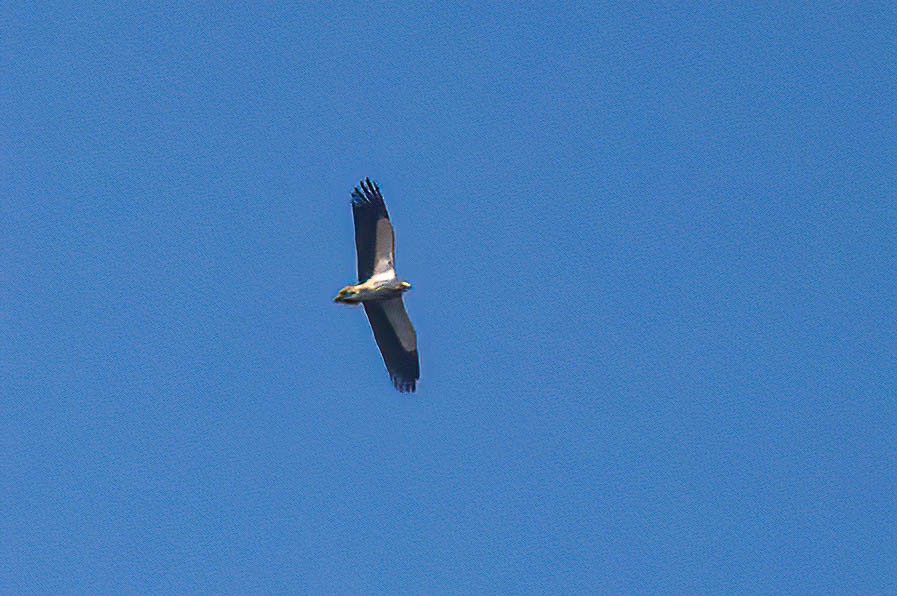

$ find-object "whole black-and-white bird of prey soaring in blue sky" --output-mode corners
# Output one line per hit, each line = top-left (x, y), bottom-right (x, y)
(333, 178), (420, 393)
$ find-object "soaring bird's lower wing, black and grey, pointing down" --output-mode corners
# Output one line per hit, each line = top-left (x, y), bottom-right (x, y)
(363, 296), (420, 393)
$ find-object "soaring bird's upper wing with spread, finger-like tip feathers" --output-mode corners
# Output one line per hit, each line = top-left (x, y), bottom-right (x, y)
(352, 178), (395, 282)
